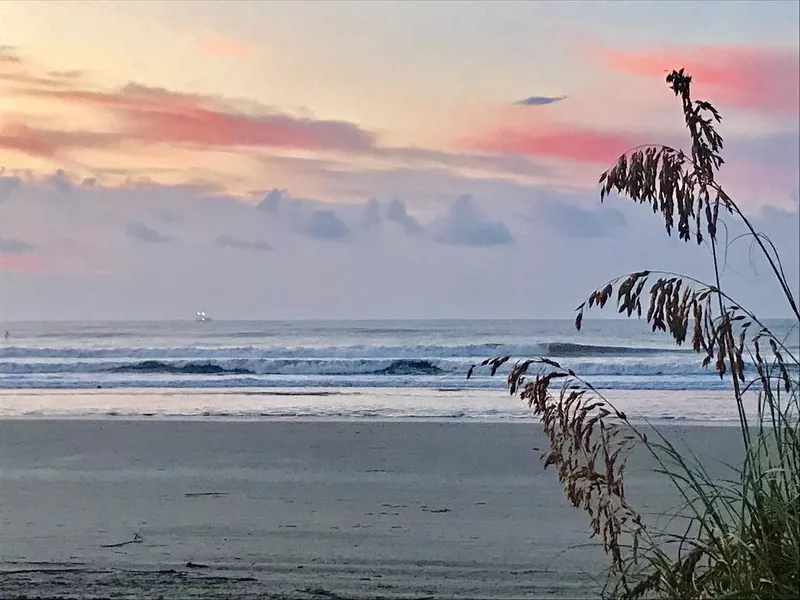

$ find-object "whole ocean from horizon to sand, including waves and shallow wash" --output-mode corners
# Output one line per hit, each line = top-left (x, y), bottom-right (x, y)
(0, 320), (800, 422)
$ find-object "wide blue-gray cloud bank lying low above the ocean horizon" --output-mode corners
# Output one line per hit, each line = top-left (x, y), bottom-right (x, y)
(0, 171), (800, 320)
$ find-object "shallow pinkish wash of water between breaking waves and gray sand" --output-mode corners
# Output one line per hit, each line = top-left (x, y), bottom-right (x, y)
(0, 388), (754, 427)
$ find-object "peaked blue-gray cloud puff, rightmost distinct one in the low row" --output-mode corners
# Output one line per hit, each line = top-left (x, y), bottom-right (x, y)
(431, 196), (513, 246)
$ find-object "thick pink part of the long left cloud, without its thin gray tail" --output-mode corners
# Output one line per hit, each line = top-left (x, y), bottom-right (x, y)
(0, 53), (375, 156)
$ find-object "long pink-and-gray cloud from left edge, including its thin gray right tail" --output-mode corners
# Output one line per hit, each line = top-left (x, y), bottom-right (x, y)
(0, 56), (564, 180)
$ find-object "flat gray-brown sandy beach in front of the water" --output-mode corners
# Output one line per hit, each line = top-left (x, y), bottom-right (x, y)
(0, 419), (737, 598)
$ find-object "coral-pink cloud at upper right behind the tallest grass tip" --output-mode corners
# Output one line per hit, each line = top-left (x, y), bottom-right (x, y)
(600, 46), (800, 116)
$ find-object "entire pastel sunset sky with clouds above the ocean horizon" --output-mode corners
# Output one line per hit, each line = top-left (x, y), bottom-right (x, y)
(0, 0), (800, 321)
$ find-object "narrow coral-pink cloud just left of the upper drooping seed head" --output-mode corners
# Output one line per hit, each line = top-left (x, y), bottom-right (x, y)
(466, 126), (641, 163)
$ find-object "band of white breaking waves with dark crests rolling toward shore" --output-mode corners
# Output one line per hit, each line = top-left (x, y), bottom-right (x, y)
(0, 341), (756, 390)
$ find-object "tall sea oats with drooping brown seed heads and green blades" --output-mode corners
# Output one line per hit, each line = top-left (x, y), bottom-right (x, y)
(468, 70), (800, 599)
